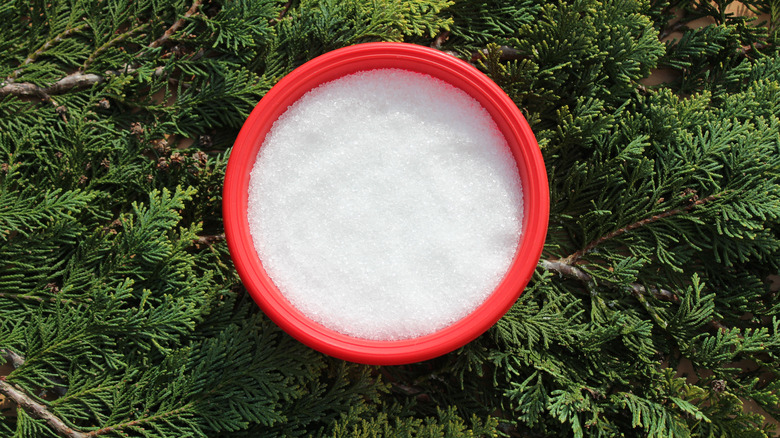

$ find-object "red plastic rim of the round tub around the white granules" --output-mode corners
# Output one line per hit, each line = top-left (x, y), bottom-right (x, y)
(222, 43), (550, 365)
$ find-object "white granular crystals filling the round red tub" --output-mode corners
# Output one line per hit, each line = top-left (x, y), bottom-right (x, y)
(247, 69), (523, 340)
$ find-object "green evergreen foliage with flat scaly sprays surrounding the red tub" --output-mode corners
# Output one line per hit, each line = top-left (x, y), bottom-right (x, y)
(0, 0), (780, 438)
